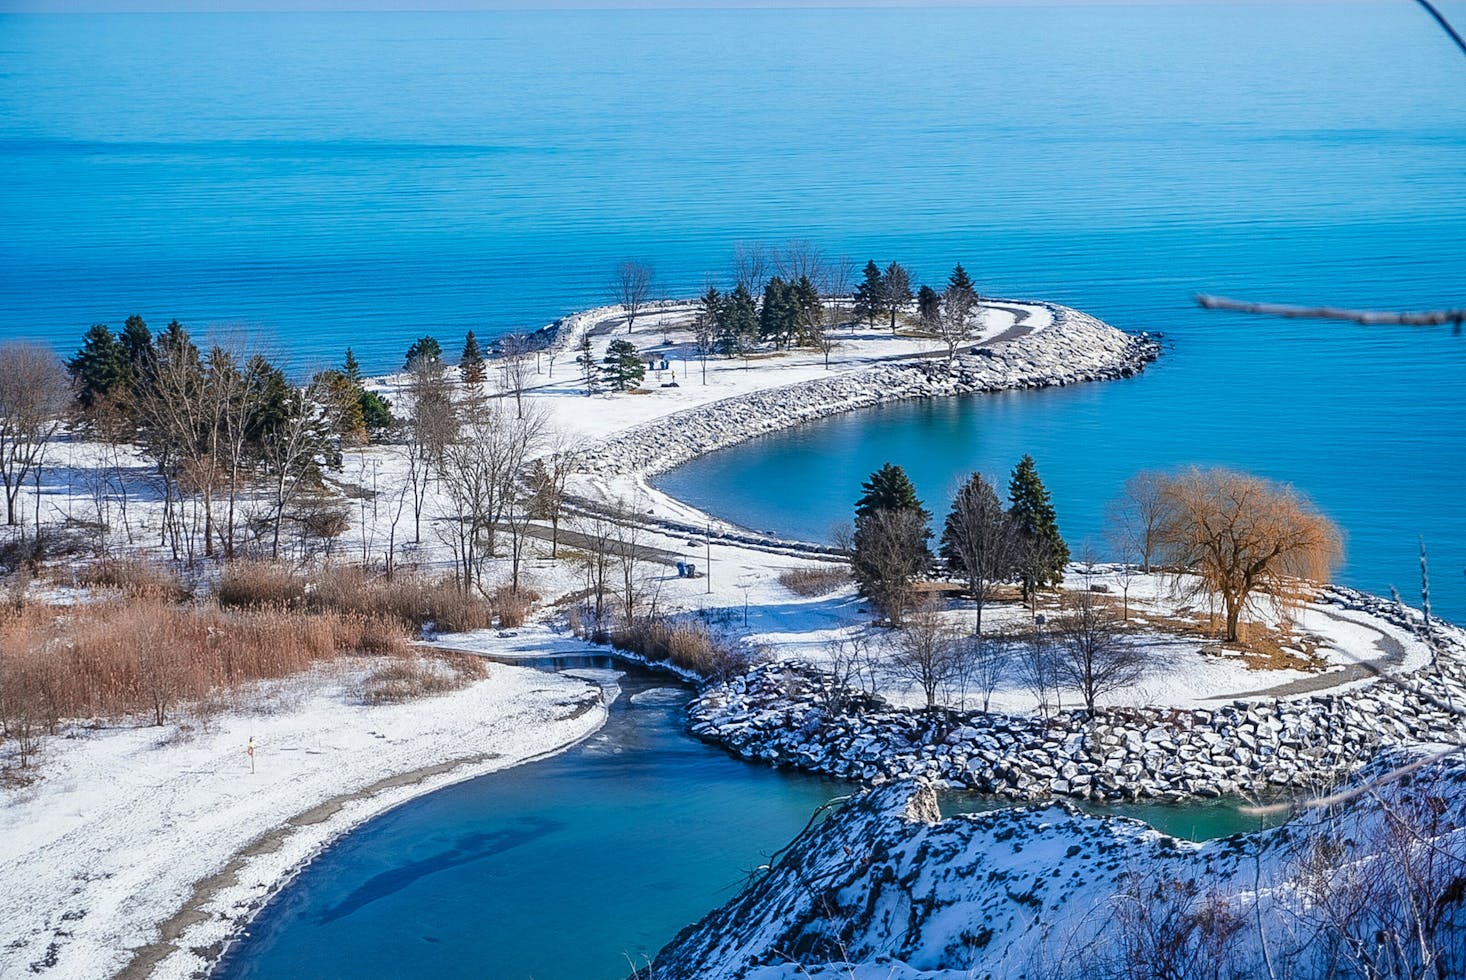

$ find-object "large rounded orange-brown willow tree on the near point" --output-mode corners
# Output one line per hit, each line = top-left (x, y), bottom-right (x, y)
(1158, 468), (1343, 643)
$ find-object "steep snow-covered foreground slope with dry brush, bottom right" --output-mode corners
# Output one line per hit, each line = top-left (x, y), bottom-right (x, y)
(649, 745), (1466, 980)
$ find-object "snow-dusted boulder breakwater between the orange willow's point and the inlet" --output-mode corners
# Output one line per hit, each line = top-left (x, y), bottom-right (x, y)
(688, 590), (1466, 801)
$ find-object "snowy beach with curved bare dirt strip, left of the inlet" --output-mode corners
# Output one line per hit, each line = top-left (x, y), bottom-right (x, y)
(0, 665), (605, 979)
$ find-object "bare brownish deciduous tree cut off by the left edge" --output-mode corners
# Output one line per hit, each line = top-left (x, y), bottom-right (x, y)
(0, 340), (70, 525)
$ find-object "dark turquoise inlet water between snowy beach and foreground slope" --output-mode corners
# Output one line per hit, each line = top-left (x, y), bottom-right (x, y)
(216, 660), (847, 980)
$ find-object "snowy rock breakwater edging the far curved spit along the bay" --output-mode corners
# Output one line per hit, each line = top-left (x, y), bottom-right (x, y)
(578, 304), (1160, 475)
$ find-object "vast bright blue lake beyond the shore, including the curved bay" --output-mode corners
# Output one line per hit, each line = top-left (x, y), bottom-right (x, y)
(0, 1), (1466, 618)
